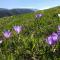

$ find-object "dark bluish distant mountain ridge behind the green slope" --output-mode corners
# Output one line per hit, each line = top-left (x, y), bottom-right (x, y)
(0, 8), (34, 18)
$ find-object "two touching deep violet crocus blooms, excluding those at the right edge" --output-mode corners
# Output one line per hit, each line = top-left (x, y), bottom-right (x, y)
(46, 32), (58, 45)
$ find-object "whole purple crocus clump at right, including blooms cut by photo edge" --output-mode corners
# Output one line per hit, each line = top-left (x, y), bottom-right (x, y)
(46, 26), (60, 45)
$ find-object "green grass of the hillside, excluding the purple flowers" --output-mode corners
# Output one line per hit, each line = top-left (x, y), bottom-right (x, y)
(0, 7), (60, 60)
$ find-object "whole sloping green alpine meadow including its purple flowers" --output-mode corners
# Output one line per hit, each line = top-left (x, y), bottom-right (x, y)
(0, 6), (60, 60)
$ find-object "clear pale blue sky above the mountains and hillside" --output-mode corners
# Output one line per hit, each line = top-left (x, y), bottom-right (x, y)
(0, 0), (60, 10)
